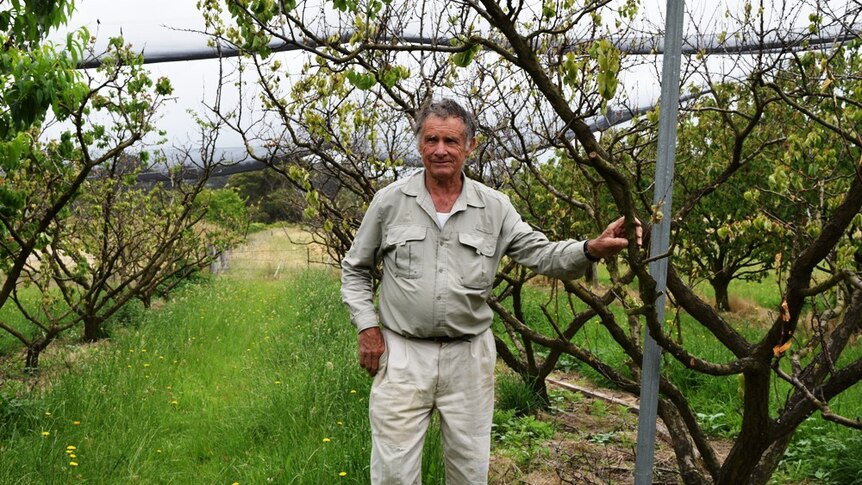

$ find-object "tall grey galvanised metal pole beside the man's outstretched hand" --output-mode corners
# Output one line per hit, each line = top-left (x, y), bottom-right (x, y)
(635, 0), (685, 485)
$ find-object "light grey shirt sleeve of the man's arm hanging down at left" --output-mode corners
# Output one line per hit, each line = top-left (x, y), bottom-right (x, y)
(341, 197), (383, 332)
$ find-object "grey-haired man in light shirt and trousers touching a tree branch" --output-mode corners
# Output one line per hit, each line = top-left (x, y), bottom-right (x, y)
(341, 100), (639, 484)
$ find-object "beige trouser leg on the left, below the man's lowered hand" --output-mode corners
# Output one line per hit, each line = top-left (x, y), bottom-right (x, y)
(368, 329), (439, 485)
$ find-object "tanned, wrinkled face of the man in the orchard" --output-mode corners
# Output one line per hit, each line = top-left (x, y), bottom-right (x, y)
(419, 116), (476, 182)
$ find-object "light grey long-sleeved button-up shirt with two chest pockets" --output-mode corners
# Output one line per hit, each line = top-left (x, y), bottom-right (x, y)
(341, 171), (590, 337)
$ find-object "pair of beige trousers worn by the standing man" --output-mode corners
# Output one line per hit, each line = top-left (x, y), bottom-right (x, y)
(369, 329), (497, 485)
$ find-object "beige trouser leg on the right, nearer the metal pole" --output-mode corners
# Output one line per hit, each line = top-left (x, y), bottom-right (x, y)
(436, 330), (496, 485)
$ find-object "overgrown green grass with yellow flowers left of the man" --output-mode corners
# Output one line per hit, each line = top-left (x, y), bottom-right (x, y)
(0, 271), (443, 484)
